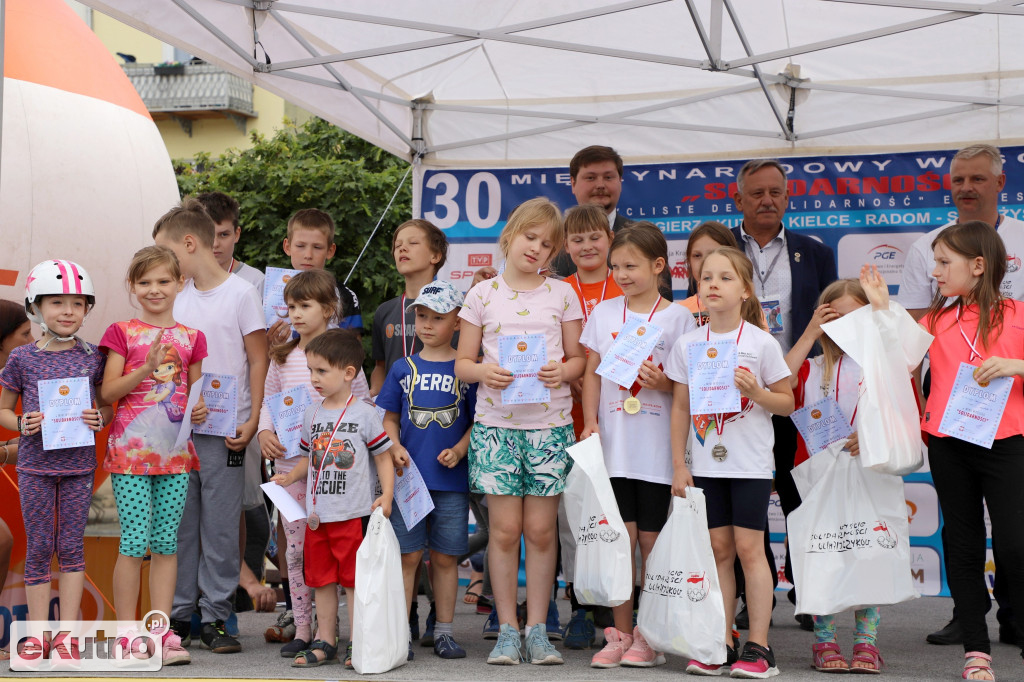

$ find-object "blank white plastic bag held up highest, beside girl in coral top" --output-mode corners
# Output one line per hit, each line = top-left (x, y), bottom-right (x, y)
(821, 301), (933, 476)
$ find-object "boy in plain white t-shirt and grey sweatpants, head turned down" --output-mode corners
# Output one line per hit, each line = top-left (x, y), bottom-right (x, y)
(153, 199), (269, 653)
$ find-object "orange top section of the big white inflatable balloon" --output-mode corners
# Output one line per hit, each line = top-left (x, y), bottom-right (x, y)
(4, 0), (151, 118)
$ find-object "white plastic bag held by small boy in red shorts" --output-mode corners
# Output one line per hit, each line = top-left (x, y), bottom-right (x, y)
(351, 509), (409, 675)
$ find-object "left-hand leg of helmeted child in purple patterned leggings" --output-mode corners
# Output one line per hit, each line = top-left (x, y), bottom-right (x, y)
(17, 471), (57, 621)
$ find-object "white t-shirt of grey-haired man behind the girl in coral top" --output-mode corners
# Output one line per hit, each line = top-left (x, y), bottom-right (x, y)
(897, 215), (1024, 309)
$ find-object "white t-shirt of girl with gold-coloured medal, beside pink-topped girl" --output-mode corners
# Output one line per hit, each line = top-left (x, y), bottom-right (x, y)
(580, 297), (696, 485)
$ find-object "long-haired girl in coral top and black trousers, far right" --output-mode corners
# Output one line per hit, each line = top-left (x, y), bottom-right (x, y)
(865, 221), (1024, 680)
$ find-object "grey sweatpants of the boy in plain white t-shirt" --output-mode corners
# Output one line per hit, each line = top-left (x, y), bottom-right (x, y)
(171, 434), (245, 623)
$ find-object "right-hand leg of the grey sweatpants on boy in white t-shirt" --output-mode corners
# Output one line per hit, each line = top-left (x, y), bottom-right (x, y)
(192, 435), (245, 623)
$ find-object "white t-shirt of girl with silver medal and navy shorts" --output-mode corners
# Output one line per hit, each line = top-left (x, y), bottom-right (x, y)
(665, 323), (792, 478)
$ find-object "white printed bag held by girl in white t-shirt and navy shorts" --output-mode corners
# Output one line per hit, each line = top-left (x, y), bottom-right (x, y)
(637, 487), (726, 664)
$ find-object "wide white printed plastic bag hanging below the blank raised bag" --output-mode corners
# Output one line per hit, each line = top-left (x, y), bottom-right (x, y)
(787, 443), (920, 615)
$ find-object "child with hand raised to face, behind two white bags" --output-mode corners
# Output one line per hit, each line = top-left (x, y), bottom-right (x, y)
(785, 279), (888, 673)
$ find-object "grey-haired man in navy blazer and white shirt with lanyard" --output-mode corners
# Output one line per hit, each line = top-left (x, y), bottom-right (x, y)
(732, 159), (837, 630)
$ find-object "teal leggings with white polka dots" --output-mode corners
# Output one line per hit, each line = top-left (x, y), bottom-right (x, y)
(111, 473), (188, 558)
